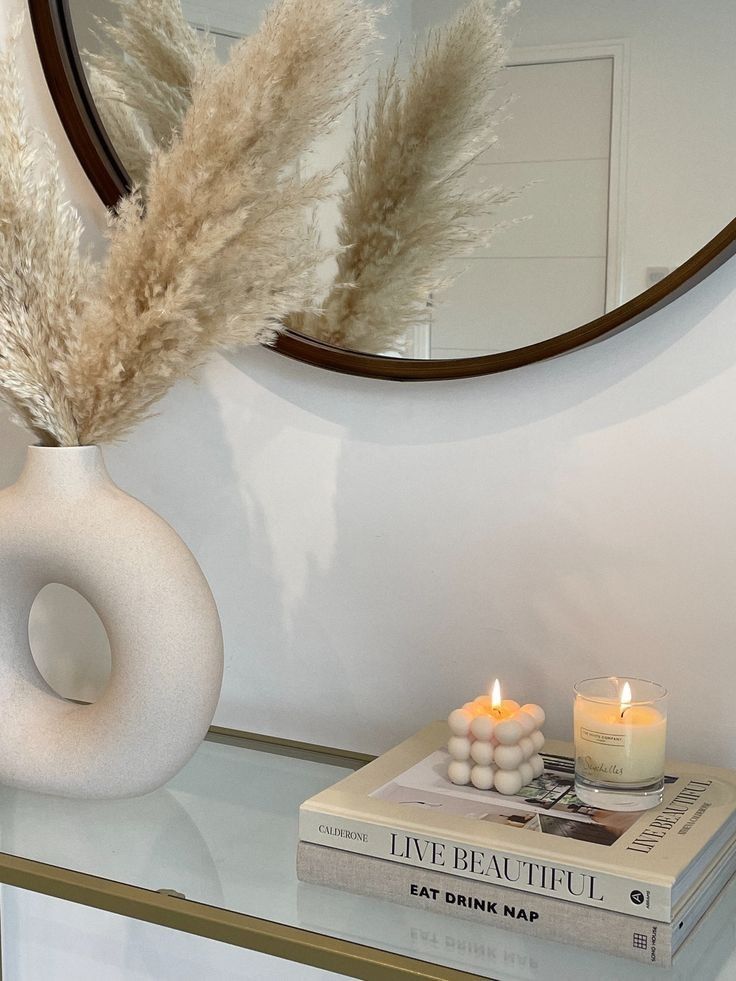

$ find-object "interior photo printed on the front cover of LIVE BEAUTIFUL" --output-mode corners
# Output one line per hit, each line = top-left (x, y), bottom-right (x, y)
(370, 750), (674, 845)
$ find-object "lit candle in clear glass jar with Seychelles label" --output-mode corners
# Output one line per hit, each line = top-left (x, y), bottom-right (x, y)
(574, 677), (667, 811)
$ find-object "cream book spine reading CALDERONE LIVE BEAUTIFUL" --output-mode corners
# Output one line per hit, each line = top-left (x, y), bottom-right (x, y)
(299, 805), (672, 923)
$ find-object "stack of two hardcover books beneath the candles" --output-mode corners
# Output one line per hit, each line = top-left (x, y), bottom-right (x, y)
(297, 722), (736, 967)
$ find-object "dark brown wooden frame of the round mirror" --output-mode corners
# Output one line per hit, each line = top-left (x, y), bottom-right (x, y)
(28, 0), (736, 381)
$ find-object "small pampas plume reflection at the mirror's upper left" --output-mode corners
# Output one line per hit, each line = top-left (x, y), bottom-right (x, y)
(84, 0), (216, 153)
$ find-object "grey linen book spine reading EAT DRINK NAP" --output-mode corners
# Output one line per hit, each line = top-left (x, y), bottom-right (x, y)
(297, 841), (672, 967)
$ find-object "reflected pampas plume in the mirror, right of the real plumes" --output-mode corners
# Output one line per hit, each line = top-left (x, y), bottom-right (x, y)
(298, 0), (516, 352)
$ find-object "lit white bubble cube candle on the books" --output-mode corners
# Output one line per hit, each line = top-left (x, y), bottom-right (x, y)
(447, 679), (545, 795)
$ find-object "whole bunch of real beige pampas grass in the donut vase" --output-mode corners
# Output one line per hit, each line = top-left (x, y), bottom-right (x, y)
(0, 0), (374, 445)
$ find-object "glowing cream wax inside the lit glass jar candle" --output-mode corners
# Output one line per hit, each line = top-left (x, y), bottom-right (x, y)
(574, 696), (667, 786)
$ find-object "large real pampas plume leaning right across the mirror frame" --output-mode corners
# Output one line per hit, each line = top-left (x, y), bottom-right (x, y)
(64, 0), (375, 443)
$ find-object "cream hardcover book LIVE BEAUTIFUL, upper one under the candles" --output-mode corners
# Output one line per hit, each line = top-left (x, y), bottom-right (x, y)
(299, 722), (736, 923)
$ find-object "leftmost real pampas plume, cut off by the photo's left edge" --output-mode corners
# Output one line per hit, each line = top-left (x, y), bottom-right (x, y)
(0, 24), (91, 445)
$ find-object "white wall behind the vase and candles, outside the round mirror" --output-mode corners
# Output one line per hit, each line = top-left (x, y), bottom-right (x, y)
(0, 11), (736, 765)
